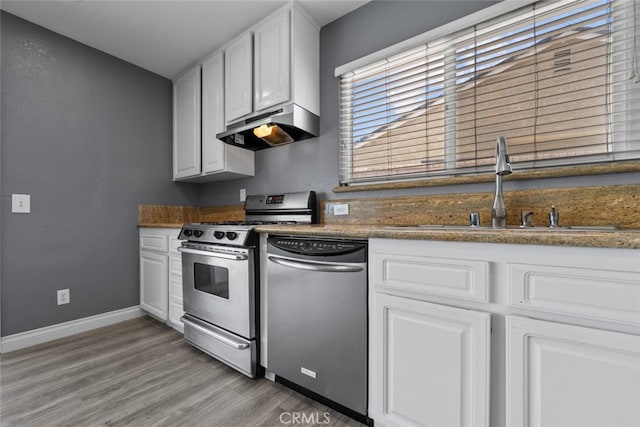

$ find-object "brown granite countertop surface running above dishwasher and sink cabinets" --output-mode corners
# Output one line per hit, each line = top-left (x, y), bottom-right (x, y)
(255, 224), (640, 249)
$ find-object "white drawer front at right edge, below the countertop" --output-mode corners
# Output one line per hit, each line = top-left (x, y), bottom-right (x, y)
(508, 263), (640, 325)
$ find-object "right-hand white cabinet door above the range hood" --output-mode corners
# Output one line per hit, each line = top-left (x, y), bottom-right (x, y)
(254, 10), (291, 111)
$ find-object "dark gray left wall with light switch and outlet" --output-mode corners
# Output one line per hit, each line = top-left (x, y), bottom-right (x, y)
(0, 12), (199, 336)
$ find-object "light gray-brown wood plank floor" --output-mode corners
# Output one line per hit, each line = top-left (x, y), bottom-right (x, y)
(0, 317), (363, 427)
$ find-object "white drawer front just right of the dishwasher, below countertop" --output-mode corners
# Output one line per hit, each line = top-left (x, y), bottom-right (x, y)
(372, 252), (489, 302)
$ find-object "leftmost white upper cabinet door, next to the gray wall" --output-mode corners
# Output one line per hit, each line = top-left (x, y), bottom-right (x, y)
(173, 66), (201, 180)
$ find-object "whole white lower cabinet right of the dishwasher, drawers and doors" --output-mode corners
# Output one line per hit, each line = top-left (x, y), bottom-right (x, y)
(369, 239), (640, 427)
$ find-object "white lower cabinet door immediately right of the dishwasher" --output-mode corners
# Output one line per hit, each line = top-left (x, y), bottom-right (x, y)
(369, 293), (490, 427)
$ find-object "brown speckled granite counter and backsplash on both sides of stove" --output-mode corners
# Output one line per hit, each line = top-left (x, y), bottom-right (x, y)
(138, 184), (640, 249)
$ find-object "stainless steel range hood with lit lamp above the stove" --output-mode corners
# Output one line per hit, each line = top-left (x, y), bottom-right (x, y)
(216, 104), (320, 151)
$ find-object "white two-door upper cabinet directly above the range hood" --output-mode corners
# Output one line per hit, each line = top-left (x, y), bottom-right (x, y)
(224, 5), (320, 124)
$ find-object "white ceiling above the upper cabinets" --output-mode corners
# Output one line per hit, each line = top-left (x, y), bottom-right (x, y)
(0, 0), (368, 78)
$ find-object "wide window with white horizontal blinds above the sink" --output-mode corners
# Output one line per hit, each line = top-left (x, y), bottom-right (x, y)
(336, 0), (640, 185)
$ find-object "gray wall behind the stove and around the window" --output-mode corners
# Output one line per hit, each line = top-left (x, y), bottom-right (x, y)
(201, 0), (638, 204)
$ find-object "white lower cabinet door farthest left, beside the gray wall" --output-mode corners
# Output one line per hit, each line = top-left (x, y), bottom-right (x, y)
(140, 251), (169, 321)
